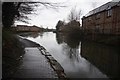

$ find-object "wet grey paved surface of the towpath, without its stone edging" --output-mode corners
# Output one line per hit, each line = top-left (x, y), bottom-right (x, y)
(13, 47), (57, 78)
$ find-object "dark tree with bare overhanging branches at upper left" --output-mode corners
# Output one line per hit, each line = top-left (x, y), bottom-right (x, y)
(2, 1), (66, 27)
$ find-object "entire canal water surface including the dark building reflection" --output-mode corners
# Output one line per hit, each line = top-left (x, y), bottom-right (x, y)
(19, 32), (119, 78)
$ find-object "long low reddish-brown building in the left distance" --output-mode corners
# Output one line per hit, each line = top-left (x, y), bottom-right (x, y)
(14, 25), (43, 32)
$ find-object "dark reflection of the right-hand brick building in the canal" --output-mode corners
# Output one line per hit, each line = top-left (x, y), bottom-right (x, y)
(81, 41), (120, 78)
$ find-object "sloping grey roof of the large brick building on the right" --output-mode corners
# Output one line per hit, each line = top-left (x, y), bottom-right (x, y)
(85, 1), (120, 17)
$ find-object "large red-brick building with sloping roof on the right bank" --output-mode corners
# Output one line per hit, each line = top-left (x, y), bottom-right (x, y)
(82, 1), (120, 34)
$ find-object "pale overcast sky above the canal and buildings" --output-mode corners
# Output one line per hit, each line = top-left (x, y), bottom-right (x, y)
(17, 0), (111, 28)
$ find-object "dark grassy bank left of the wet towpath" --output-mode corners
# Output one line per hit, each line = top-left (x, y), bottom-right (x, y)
(2, 29), (24, 78)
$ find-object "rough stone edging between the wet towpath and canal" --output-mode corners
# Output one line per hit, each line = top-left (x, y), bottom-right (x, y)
(18, 36), (67, 80)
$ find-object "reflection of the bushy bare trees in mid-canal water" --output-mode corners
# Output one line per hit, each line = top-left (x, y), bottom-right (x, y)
(56, 33), (80, 62)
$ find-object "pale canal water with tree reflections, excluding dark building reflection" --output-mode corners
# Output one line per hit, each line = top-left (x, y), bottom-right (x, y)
(19, 32), (107, 78)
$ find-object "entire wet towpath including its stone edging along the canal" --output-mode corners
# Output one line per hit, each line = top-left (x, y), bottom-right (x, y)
(10, 36), (66, 79)
